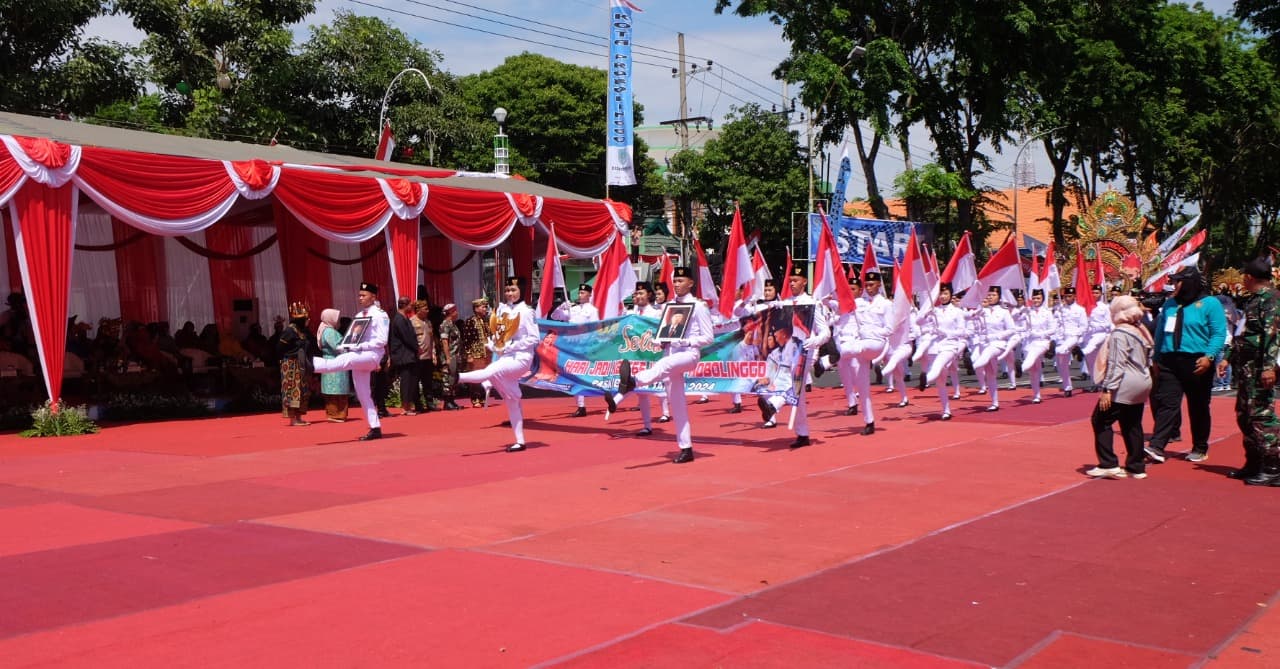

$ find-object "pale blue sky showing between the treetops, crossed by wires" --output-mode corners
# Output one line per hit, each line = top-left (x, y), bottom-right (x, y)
(88, 0), (1231, 197)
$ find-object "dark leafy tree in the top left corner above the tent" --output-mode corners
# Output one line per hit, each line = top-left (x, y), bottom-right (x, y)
(0, 0), (142, 115)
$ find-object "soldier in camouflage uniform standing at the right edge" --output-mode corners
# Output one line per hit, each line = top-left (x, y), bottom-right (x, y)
(1217, 258), (1280, 487)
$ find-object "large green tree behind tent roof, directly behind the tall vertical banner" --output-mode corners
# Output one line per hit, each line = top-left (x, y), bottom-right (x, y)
(451, 52), (662, 211)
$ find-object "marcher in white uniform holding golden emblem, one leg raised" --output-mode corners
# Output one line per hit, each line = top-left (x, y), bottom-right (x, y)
(458, 276), (541, 453)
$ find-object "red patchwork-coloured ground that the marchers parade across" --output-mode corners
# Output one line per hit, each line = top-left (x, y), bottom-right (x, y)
(0, 388), (1280, 669)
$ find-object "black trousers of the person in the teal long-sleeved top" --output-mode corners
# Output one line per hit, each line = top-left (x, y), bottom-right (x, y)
(1151, 353), (1213, 453)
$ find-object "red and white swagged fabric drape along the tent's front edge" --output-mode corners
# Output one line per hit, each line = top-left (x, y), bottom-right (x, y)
(0, 136), (631, 398)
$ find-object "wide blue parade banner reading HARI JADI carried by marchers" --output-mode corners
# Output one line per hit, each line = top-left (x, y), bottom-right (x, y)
(521, 304), (813, 404)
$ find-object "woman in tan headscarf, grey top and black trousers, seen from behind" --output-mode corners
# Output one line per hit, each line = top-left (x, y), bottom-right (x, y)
(1084, 295), (1155, 478)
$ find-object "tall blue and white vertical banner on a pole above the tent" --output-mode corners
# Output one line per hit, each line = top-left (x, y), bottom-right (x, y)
(604, 0), (641, 185)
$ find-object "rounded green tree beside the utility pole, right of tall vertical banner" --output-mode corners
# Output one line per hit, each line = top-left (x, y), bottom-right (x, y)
(668, 105), (809, 272)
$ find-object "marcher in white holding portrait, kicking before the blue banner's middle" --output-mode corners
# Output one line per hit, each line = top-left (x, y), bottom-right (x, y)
(604, 267), (714, 464)
